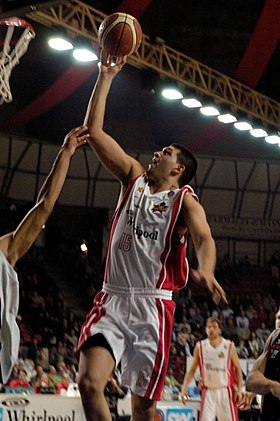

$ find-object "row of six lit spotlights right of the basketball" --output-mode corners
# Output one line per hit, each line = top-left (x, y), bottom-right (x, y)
(162, 88), (280, 147)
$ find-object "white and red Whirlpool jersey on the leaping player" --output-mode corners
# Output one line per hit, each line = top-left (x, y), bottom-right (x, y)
(105, 175), (197, 290)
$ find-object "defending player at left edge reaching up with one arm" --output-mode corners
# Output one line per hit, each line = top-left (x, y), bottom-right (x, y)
(0, 126), (88, 384)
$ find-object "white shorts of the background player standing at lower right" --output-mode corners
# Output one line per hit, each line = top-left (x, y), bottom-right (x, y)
(199, 387), (238, 421)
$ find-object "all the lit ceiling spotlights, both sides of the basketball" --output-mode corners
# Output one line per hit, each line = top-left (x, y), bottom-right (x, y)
(48, 36), (280, 147)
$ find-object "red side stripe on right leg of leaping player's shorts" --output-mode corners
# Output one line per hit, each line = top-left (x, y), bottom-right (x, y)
(145, 299), (175, 401)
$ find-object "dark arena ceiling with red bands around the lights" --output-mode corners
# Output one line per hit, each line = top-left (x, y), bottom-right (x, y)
(0, 0), (280, 162)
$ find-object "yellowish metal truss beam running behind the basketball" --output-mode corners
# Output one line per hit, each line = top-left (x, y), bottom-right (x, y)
(26, 0), (280, 130)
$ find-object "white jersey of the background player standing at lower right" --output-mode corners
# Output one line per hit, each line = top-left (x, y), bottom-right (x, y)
(199, 338), (235, 388)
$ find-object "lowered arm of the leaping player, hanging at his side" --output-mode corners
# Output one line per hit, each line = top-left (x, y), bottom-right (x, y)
(182, 194), (227, 304)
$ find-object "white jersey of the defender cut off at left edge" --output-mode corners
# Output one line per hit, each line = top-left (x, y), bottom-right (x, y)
(0, 250), (20, 383)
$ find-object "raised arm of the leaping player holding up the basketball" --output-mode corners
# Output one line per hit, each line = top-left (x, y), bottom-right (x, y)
(84, 50), (144, 185)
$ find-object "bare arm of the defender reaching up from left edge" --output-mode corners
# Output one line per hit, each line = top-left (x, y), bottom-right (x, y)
(0, 126), (89, 266)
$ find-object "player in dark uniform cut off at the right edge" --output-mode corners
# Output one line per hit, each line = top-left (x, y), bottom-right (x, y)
(246, 310), (280, 421)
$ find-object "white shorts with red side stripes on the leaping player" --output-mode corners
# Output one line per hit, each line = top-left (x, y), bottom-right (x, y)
(78, 284), (175, 400)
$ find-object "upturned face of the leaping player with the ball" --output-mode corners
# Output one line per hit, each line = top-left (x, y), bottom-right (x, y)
(147, 146), (182, 178)
